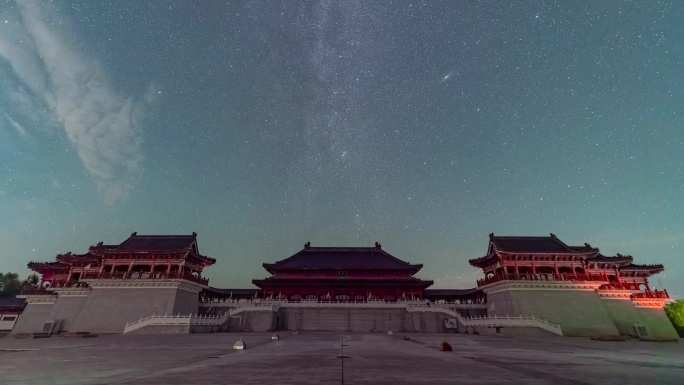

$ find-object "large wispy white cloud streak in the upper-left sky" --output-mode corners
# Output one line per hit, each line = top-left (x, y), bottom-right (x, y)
(0, 0), (149, 205)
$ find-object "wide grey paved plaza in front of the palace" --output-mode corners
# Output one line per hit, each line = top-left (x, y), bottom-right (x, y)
(0, 332), (684, 385)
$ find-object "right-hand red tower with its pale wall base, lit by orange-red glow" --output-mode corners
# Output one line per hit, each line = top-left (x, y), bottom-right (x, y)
(469, 234), (676, 338)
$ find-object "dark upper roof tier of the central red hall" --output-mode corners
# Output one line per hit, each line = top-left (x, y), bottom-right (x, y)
(264, 245), (423, 272)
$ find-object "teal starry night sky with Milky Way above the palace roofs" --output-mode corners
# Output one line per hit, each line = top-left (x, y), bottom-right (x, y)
(0, 0), (684, 298)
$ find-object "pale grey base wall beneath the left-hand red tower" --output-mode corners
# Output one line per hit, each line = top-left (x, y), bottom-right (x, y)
(69, 287), (178, 333)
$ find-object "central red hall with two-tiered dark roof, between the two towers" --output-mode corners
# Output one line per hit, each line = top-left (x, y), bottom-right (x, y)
(252, 242), (432, 301)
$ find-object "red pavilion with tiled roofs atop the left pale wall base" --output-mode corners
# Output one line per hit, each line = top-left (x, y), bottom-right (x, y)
(28, 233), (216, 287)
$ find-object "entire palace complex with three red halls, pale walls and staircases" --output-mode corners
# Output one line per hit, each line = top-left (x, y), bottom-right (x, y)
(10, 233), (677, 339)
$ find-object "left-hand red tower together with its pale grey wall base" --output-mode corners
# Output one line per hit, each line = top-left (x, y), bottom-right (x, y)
(13, 233), (216, 333)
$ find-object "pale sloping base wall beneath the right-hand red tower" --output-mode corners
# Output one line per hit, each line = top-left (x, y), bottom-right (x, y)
(487, 289), (620, 337)
